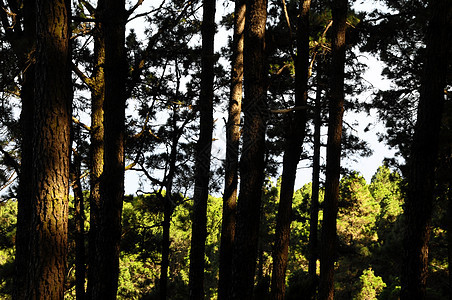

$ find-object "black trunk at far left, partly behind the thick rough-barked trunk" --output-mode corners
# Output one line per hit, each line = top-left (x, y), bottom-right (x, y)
(11, 0), (36, 299)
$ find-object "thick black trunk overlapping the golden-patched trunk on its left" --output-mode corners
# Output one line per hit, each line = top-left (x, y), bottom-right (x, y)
(90, 0), (127, 299)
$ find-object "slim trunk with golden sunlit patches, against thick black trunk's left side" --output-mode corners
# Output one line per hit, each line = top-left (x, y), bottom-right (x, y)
(87, 0), (105, 299)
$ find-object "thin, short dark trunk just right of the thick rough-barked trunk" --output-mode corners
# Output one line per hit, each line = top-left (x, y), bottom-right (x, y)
(70, 128), (86, 300)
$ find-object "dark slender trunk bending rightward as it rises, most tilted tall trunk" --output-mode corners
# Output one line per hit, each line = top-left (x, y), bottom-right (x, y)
(271, 0), (311, 300)
